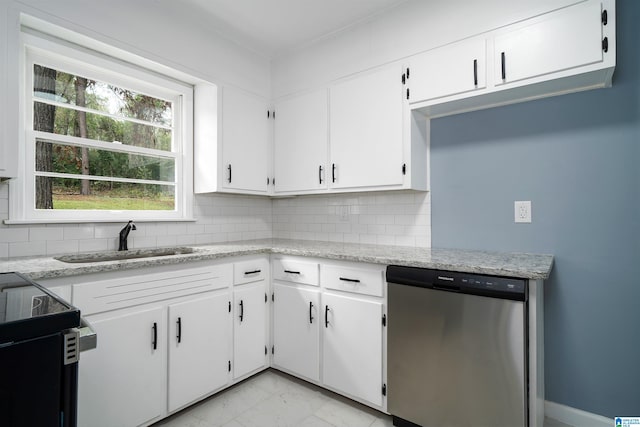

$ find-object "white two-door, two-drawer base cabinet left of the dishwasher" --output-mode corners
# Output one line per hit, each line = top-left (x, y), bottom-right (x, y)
(272, 256), (386, 411)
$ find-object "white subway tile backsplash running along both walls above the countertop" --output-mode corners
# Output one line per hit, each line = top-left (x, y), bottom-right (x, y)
(0, 180), (431, 258)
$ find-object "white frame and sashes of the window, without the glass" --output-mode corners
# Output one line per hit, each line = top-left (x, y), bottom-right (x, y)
(7, 29), (193, 223)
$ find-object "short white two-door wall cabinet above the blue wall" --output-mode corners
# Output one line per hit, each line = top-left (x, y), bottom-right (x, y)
(408, 0), (616, 118)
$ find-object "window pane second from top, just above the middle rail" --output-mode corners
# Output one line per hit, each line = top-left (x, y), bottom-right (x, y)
(33, 102), (172, 151)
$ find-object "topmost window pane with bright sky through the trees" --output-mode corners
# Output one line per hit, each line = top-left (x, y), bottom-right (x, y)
(33, 64), (173, 126)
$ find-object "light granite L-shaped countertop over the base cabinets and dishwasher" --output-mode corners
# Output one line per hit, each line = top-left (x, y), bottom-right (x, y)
(0, 239), (553, 280)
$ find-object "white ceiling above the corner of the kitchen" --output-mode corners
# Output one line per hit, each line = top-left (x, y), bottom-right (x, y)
(172, 0), (407, 57)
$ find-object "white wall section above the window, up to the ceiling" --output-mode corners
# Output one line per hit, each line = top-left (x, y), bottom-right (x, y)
(10, 0), (270, 96)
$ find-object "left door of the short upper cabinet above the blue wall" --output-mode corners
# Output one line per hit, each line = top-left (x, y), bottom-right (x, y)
(408, 38), (487, 104)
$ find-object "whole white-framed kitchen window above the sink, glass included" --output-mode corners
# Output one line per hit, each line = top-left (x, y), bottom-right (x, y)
(10, 33), (193, 222)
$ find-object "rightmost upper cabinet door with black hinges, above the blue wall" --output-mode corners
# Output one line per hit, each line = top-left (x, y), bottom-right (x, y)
(494, 2), (603, 85)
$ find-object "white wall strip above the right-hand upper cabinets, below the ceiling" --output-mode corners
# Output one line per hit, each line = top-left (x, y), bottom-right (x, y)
(271, 0), (579, 98)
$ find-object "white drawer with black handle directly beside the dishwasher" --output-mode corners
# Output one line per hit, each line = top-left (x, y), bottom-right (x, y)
(320, 264), (385, 297)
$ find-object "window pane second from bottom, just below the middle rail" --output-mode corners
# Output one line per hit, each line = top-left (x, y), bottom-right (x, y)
(36, 139), (175, 182)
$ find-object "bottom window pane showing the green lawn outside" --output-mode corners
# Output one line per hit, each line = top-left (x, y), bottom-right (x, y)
(36, 177), (175, 211)
